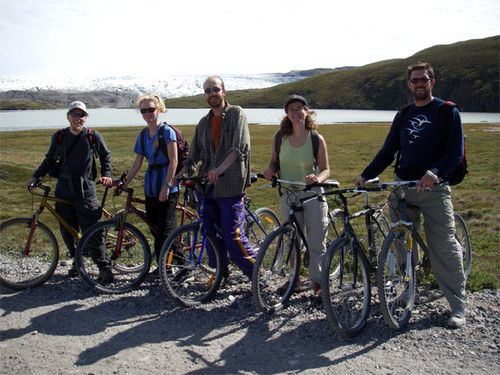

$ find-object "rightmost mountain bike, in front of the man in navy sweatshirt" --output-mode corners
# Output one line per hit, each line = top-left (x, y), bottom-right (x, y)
(377, 181), (472, 329)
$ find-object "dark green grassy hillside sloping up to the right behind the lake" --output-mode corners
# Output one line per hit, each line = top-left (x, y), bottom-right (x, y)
(167, 36), (500, 112)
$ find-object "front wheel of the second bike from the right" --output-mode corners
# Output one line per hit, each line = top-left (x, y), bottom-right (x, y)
(321, 237), (371, 337)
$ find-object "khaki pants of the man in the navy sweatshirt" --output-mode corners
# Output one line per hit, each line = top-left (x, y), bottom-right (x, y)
(390, 185), (467, 311)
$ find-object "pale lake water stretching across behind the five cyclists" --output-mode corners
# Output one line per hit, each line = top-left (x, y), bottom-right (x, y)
(0, 108), (500, 131)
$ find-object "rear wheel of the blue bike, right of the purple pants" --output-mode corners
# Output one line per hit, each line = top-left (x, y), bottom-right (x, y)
(245, 207), (280, 253)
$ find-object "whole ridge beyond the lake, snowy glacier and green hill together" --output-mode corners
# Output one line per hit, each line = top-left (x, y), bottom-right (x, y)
(0, 35), (500, 112)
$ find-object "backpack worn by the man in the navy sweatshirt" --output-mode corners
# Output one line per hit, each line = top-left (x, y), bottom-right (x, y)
(394, 100), (469, 186)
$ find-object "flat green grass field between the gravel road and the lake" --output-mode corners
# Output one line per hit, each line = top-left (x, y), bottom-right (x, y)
(0, 124), (500, 290)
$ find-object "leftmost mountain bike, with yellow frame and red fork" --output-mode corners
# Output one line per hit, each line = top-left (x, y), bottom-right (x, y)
(0, 179), (116, 290)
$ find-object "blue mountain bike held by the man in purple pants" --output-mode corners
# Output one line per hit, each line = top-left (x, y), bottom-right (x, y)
(160, 176), (279, 307)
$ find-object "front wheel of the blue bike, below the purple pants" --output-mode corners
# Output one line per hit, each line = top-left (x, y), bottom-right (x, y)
(159, 223), (222, 307)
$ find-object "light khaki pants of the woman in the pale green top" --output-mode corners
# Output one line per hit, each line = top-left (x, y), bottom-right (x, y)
(281, 191), (328, 283)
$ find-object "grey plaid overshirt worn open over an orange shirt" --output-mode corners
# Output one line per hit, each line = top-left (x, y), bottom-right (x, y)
(189, 103), (250, 198)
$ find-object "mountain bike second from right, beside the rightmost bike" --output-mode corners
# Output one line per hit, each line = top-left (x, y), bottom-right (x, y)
(321, 179), (389, 338)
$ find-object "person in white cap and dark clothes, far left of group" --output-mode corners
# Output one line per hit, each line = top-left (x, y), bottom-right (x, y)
(27, 101), (113, 282)
